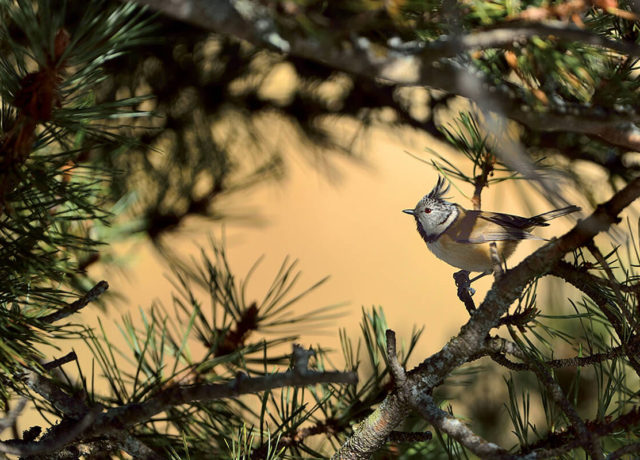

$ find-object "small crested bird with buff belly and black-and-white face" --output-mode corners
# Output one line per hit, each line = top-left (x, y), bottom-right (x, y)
(402, 177), (580, 273)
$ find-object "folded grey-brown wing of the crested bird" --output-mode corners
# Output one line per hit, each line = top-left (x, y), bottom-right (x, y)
(452, 211), (544, 243)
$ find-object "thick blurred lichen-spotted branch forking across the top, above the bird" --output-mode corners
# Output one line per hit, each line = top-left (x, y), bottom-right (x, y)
(138, 0), (640, 150)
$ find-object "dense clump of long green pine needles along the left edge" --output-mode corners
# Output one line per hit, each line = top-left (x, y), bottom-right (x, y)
(0, 0), (149, 380)
